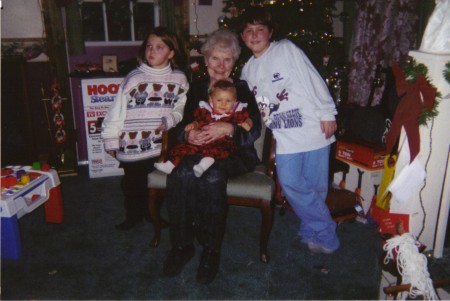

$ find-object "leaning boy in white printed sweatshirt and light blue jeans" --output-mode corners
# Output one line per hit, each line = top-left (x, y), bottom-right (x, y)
(241, 7), (339, 254)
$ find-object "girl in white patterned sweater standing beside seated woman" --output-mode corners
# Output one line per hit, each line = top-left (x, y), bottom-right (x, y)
(102, 27), (189, 230)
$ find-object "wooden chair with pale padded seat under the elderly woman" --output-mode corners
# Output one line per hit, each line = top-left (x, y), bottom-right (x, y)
(148, 125), (275, 263)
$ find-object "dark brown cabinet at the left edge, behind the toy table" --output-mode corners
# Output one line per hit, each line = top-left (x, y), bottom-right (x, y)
(1, 57), (53, 166)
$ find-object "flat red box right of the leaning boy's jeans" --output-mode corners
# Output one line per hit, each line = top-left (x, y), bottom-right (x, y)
(336, 141), (386, 170)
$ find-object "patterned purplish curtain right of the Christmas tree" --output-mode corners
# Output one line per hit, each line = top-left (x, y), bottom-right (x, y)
(348, 0), (420, 106)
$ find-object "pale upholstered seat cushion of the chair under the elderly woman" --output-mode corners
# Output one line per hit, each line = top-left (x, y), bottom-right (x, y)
(147, 166), (275, 201)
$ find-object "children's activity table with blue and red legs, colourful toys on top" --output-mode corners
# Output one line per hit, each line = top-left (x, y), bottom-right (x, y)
(0, 162), (63, 259)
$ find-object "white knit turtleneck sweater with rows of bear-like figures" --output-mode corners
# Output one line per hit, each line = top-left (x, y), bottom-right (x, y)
(102, 64), (189, 162)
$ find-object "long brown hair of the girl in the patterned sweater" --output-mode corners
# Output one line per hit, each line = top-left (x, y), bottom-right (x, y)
(138, 27), (188, 71)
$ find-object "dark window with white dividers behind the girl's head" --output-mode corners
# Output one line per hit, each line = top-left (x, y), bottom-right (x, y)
(81, 0), (159, 45)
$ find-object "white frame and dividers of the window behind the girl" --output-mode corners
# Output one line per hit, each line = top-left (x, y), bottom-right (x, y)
(80, 0), (160, 47)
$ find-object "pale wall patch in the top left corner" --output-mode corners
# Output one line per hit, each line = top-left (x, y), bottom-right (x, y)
(1, 0), (44, 39)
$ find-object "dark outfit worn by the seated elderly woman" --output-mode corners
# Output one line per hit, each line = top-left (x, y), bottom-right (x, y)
(163, 80), (261, 283)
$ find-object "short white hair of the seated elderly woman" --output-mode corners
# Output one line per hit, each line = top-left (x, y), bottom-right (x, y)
(201, 28), (241, 62)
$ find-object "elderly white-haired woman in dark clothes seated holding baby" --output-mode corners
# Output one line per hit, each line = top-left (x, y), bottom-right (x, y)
(163, 29), (261, 284)
